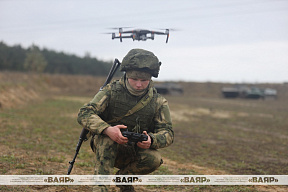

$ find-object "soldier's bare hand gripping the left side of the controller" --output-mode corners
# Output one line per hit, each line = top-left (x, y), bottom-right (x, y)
(103, 125), (128, 144)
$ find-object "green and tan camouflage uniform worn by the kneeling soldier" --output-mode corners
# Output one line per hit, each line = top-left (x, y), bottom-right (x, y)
(78, 49), (174, 191)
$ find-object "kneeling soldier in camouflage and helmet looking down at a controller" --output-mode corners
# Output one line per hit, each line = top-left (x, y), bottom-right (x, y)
(78, 49), (174, 191)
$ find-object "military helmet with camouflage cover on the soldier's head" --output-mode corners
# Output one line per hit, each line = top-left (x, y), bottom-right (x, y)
(120, 49), (161, 77)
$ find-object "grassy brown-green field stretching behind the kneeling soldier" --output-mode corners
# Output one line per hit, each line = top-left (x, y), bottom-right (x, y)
(0, 74), (288, 192)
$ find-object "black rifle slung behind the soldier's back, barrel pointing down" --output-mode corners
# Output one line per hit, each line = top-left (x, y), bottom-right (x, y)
(67, 59), (121, 175)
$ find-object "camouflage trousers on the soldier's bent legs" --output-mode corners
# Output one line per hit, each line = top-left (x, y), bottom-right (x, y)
(94, 135), (163, 175)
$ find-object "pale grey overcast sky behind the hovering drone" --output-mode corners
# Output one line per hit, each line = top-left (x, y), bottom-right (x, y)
(0, 0), (288, 83)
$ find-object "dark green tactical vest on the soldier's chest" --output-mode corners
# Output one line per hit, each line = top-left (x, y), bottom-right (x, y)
(100, 81), (158, 133)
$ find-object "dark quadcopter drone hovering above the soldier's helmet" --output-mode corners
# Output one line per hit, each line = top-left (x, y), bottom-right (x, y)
(112, 28), (169, 43)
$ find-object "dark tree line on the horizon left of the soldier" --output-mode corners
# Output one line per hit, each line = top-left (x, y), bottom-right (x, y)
(0, 42), (112, 76)
